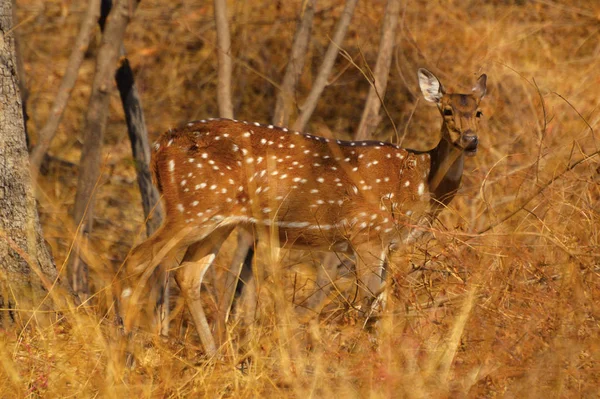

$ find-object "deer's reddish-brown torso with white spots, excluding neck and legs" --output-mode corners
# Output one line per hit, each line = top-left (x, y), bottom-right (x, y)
(152, 120), (430, 249)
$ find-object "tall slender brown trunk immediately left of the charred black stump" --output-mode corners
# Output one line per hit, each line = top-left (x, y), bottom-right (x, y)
(69, 0), (139, 298)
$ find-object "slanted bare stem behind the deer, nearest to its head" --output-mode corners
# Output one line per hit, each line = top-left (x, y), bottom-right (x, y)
(355, 0), (400, 140)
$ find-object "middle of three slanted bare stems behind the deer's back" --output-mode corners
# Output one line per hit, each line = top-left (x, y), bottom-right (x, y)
(294, 0), (358, 131)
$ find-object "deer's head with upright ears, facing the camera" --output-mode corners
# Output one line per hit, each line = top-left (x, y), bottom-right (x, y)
(418, 68), (487, 156)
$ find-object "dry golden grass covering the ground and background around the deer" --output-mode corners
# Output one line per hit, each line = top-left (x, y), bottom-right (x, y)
(0, 0), (600, 398)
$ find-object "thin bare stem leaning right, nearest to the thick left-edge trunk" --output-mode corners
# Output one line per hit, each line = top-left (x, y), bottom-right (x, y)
(29, 0), (100, 175)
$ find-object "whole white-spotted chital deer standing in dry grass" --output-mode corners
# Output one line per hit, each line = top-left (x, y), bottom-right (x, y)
(122, 69), (486, 354)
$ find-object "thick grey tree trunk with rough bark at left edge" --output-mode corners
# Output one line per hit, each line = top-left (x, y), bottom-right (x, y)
(0, 1), (68, 327)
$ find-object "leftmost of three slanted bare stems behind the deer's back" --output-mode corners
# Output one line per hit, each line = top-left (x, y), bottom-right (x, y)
(273, 0), (316, 126)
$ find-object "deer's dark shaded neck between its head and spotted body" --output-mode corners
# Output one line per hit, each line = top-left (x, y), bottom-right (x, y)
(428, 125), (465, 214)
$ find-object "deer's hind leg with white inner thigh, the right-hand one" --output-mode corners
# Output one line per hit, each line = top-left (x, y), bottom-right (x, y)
(175, 226), (235, 356)
